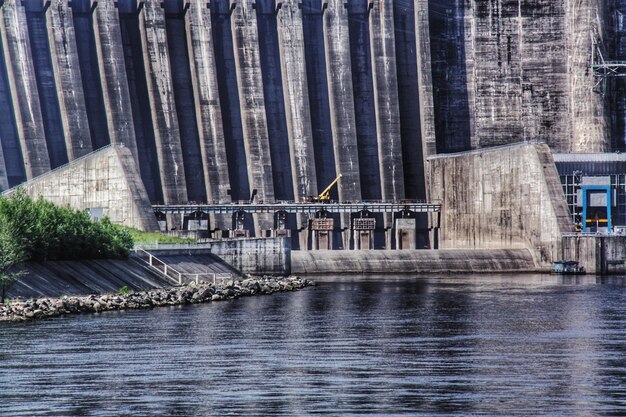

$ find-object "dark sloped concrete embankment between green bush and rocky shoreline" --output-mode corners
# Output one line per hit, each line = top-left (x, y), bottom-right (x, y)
(8, 258), (172, 297)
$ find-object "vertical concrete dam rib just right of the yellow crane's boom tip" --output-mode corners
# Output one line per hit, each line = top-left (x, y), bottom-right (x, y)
(323, 0), (361, 202)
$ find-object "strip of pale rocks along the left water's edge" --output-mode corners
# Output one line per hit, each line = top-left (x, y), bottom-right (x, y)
(0, 276), (315, 322)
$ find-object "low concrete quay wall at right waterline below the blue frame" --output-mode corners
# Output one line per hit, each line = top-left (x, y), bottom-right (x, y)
(561, 234), (626, 275)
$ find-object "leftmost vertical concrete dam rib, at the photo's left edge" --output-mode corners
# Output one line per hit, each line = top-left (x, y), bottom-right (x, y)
(0, 0), (50, 179)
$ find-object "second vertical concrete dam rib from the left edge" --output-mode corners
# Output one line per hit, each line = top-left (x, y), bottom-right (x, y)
(46, 0), (92, 160)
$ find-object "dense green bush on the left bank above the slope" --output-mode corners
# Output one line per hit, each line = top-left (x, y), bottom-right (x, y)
(0, 189), (133, 261)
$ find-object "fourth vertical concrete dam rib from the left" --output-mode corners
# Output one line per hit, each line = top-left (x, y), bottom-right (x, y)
(139, 0), (188, 204)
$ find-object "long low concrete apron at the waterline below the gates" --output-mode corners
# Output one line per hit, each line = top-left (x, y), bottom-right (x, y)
(291, 249), (538, 274)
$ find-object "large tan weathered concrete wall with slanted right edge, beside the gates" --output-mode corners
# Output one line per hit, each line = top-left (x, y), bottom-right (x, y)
(428, 145), (574, 266)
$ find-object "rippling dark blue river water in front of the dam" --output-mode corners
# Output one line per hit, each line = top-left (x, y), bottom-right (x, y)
(0, 275), (626, 416)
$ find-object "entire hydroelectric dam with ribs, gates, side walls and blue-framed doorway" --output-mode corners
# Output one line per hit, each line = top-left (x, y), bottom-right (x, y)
(0, 0), (626, 273)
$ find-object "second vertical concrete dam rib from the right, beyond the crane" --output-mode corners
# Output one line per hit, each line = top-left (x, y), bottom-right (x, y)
(369, 0), (404, 201)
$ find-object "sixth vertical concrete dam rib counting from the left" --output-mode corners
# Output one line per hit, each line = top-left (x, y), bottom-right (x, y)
(231, 0), (274, 231)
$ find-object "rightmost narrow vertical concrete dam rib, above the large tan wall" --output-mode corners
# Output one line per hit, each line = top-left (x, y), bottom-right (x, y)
(415, 0), (437, 193)
